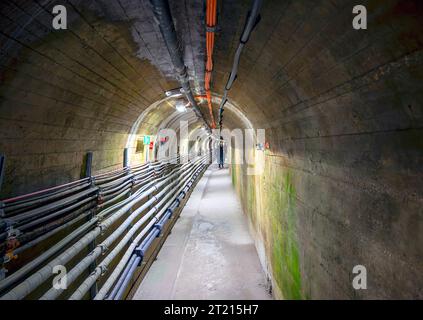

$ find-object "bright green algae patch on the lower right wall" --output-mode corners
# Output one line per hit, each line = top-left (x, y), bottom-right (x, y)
(265, 172), (303, 299)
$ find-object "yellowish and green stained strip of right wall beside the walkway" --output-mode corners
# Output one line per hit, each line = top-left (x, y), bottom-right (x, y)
(231, 154), (306, 299)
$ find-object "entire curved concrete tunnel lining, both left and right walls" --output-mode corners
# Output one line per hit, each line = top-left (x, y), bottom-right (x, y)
(0, 0), (423, 299)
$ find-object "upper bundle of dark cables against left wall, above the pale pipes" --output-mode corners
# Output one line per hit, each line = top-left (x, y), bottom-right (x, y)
(0, 164), (164, 268)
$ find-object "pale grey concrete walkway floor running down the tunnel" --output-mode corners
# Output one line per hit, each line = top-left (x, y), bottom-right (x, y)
(134, 165), (271, 300)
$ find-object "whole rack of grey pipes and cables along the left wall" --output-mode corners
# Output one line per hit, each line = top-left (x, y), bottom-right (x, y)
(0, 153), (208, 299)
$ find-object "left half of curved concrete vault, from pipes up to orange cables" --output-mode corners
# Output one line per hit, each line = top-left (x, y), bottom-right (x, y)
(0, 0), (262, 195)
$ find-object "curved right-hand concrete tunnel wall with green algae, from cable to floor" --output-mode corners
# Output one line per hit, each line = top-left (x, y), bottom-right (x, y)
(227, 1), (423, 299)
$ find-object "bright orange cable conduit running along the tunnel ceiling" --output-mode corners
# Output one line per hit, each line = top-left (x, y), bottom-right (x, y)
(204, 0), (217, 129)
